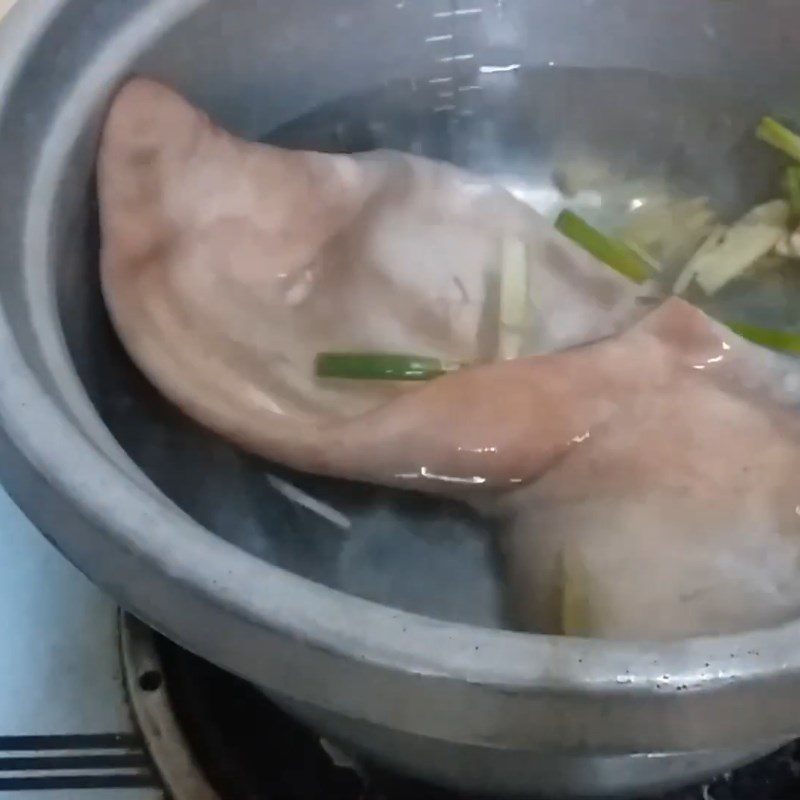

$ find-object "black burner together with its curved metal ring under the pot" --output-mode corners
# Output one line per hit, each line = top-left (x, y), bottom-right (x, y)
(122, 616), (800, 800)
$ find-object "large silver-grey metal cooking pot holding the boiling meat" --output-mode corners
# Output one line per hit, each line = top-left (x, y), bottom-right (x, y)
(0, 0), (800, 796)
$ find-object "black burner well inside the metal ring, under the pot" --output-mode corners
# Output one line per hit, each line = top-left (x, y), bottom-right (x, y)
(159, 640), (800, 800)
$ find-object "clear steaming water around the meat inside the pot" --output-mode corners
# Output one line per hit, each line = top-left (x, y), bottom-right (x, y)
(92, 69), (800, 627)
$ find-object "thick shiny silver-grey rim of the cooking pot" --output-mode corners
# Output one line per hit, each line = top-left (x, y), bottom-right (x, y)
(0, 0), (800, 749)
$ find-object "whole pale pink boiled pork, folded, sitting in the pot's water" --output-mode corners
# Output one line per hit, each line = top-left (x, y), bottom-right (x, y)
(99, 80), (800, 638)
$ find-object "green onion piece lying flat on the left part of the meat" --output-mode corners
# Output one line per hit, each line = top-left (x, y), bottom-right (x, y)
(315, 353), (461, 381)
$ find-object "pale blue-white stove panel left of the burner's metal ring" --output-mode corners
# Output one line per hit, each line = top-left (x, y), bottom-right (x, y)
(0, 488), (161, 800)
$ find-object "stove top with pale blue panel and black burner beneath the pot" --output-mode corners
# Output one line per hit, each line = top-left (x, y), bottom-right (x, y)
(0, 482), (800, 800)
